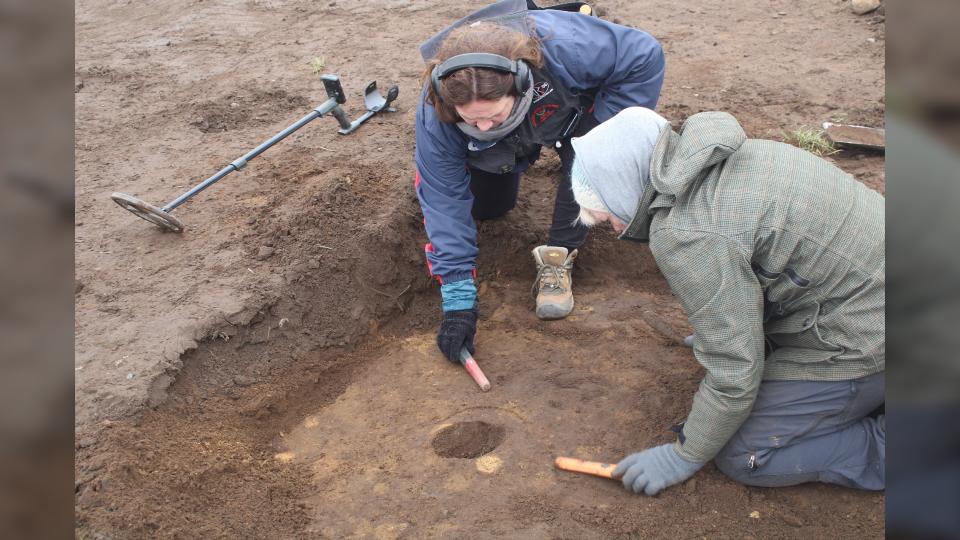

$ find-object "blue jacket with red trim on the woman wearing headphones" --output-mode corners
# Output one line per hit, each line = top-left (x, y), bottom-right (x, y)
(415, 9), (665, 284)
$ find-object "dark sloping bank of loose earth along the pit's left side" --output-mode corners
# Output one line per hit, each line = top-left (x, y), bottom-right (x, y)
(75, 159), (436, 537)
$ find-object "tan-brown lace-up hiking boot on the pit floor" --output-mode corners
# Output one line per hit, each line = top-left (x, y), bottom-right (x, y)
(533, 246), (577, 320)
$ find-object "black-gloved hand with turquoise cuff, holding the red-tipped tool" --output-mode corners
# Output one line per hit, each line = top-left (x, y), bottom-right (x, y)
(437, 279), (478, 364)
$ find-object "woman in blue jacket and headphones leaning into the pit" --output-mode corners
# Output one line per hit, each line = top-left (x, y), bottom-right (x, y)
(415, 0), (664, 362)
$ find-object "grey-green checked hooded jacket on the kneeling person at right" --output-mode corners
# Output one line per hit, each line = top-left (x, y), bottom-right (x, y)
(622, 112), (885, 462)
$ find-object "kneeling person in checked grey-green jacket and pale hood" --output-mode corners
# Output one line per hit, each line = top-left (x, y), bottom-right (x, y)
(571, 107), (886, 495)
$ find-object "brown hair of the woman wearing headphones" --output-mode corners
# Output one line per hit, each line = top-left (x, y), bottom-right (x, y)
(421, 21), (543, 123)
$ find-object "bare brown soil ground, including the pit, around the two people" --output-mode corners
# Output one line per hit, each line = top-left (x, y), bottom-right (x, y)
(75, 0), (884, 538)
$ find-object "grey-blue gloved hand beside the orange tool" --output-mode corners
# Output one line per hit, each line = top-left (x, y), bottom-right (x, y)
(613, 443), (703, 495)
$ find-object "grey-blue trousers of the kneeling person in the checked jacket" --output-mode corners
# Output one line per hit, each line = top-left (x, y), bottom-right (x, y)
(715, 373), (886, 490)
